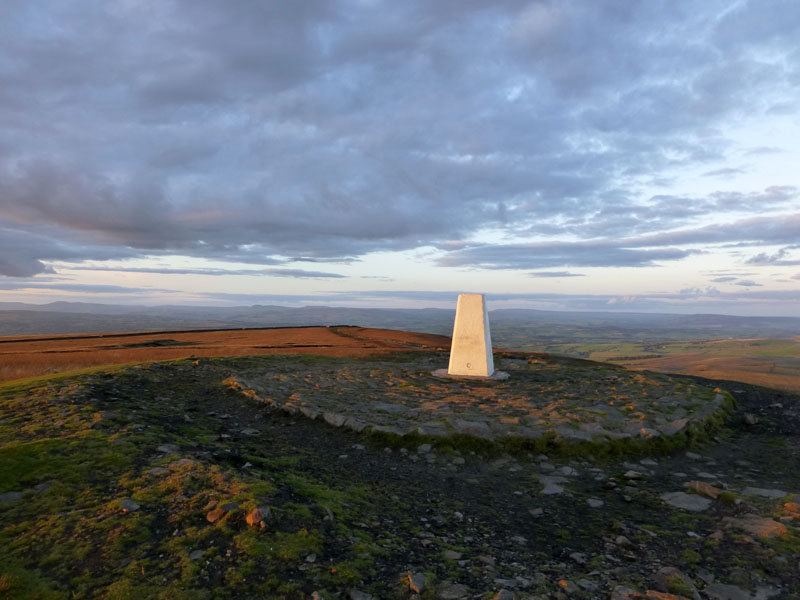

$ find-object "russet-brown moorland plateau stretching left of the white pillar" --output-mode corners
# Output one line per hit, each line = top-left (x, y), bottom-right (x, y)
(0, 326), (450, 381)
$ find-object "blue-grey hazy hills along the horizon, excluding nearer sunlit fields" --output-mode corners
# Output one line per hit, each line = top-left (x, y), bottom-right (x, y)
(0, 302), (800, 349)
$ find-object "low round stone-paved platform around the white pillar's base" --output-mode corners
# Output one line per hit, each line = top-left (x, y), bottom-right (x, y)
(226, 352), (733, 444)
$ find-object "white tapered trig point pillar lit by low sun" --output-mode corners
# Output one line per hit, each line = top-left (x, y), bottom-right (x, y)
(447, 294), (494, 377)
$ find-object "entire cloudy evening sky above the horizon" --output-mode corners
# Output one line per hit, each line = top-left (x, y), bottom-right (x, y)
(0, 0), (800, 316)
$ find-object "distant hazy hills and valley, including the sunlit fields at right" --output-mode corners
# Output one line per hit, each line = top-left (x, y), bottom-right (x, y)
(6, 302), (800, 390)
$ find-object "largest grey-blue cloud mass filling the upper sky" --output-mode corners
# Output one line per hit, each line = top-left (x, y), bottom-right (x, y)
(0, 0), (800, 276)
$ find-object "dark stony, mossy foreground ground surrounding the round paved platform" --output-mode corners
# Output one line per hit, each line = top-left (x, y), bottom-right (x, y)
(0, 357), (800, 600)
